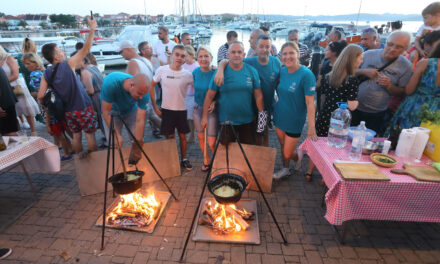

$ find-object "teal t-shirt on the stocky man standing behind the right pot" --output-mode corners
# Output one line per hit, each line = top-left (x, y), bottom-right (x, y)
(209, 63), (260, 125)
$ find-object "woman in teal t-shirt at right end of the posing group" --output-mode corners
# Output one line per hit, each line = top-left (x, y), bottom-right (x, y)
(273, 42), (317, 179)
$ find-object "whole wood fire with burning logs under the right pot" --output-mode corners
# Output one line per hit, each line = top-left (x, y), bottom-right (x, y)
(206, 202), (249, 234)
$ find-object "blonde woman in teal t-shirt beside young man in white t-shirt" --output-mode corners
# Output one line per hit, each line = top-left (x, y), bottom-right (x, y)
(192, 47), (218, 171)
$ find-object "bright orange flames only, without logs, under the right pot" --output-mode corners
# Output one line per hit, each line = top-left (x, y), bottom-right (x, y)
(208, 202), (243, 233)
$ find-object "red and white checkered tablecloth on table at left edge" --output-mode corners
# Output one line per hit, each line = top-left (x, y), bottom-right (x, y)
(0, 137), (60, 172)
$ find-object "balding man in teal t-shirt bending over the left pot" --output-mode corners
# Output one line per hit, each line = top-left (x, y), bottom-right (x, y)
(101, 72), (150, 153)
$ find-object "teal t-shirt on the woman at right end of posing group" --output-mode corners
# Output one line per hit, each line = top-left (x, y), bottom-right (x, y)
(273, 66), (316, 134)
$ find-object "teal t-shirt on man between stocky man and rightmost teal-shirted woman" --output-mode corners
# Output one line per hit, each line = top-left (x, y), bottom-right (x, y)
(244, 56), (281, 113)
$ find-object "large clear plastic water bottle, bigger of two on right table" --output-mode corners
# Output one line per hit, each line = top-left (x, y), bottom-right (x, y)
(327, 103), (351, 148)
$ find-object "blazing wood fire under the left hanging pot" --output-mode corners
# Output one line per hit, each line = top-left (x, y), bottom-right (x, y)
(107, 192), (160, 227)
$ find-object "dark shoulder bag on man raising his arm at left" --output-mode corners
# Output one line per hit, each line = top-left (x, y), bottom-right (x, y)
(42, 64), (65, 122)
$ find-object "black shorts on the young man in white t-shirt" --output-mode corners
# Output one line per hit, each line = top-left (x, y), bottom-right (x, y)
(160, 109), (190, 136)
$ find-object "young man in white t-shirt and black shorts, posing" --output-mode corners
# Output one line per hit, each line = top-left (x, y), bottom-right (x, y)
(150, 45), (193, 170)
